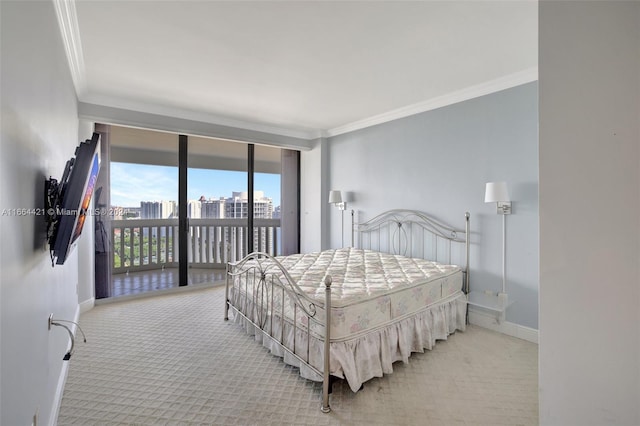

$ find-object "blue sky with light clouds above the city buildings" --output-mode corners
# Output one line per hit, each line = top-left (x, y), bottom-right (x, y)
(110, 162), (280, 207)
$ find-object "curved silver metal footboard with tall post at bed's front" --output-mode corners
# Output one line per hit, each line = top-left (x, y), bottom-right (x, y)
(224, 252), (331, 413)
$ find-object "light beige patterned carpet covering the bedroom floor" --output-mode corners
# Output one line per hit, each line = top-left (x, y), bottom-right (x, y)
(58, 287), (538, 426)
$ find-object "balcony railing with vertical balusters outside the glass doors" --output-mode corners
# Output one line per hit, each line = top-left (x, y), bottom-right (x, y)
(111, 219), (280, 274)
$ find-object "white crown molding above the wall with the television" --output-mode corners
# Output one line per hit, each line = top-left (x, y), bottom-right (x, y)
(53, 0), (87, 98)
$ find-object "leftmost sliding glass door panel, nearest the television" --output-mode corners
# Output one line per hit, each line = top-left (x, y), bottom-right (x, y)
(106, 126), (180, 297)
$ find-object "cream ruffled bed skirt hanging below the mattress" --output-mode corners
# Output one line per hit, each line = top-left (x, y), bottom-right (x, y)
(231, 292), (467, 392)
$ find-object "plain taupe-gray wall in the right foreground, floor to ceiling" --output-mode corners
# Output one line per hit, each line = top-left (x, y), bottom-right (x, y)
(539, 1), (640, 425)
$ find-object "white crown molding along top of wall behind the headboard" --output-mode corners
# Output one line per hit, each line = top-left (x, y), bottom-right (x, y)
(323, 66), (538, 137)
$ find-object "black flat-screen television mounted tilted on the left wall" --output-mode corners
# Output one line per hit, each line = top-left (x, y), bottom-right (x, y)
(49, 133), (100, 265)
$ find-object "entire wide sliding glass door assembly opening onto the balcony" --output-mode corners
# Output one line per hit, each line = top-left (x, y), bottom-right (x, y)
(103, 126), (298, 297)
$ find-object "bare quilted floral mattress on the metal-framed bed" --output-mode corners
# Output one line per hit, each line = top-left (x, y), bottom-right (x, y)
(232, 248), (463, 342)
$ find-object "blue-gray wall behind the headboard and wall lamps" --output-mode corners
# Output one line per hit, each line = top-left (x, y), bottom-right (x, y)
(328, 83), (538, 329)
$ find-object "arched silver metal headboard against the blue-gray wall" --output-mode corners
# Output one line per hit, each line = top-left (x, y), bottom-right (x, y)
(351, 209), (470, 293)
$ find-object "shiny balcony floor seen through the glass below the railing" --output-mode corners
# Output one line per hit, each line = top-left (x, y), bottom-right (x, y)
(111, 268), (225, 297)
